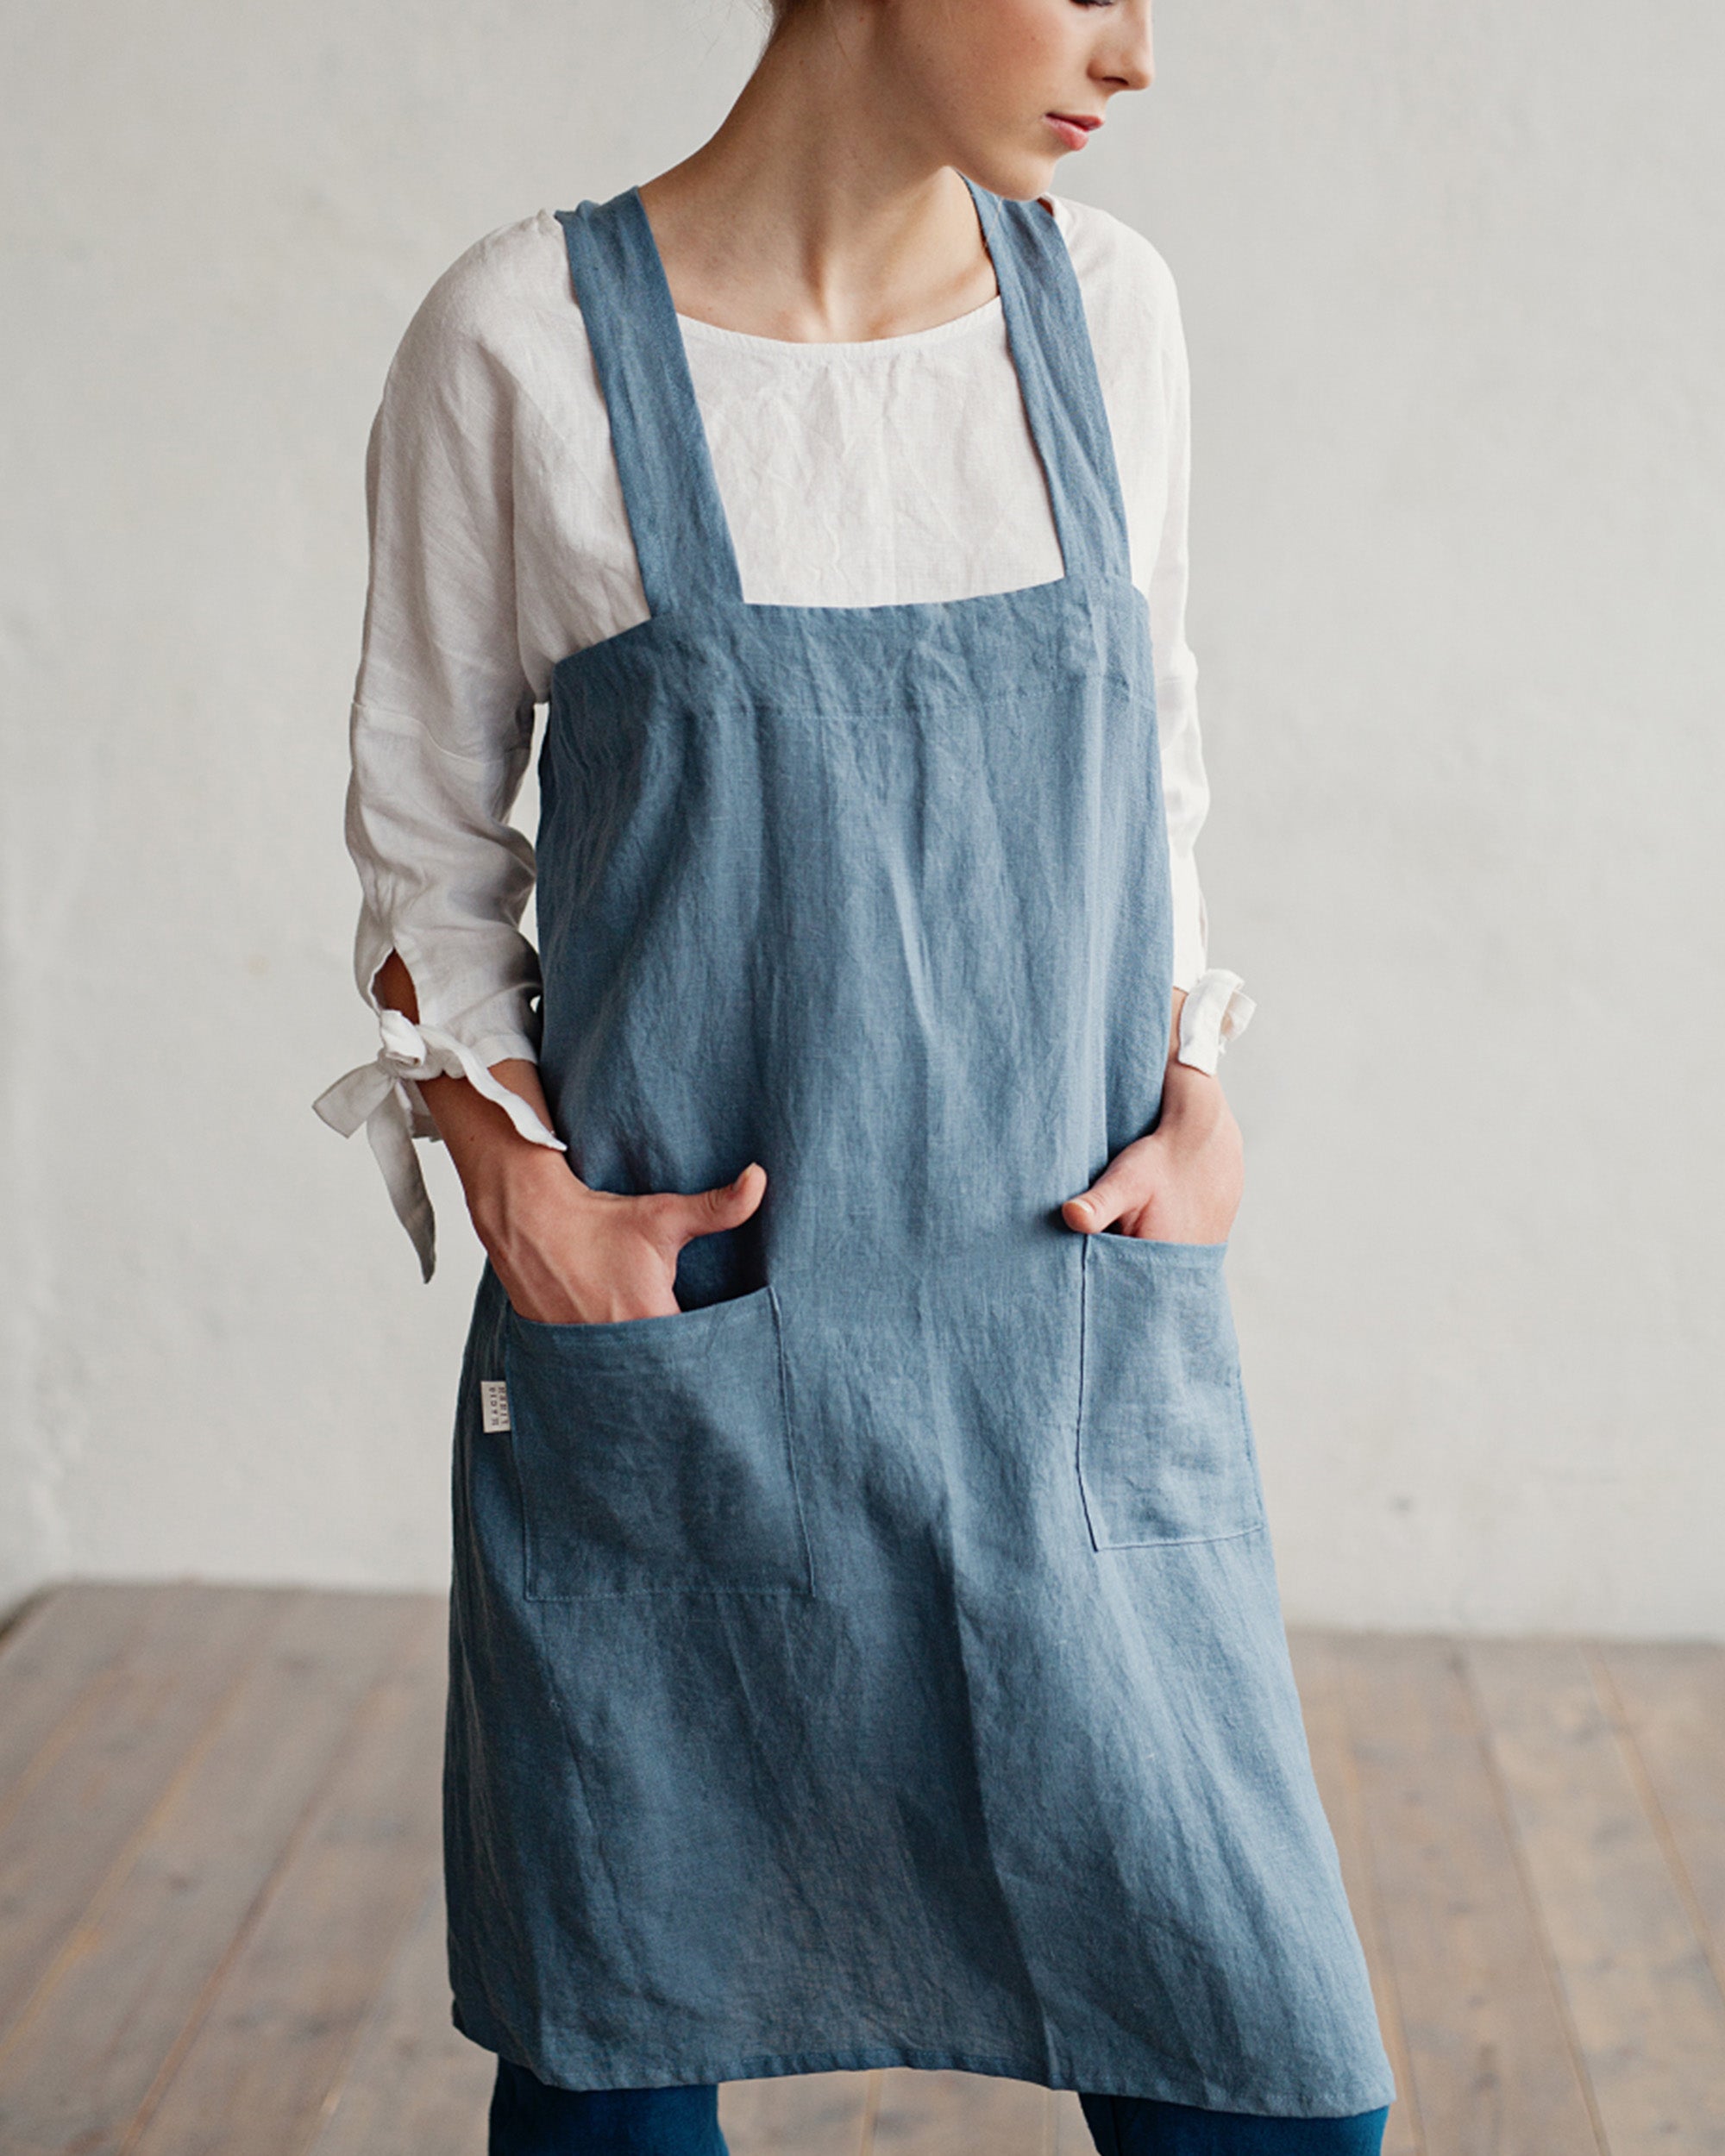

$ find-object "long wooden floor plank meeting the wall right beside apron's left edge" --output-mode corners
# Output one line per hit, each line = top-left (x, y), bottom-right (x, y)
(125, 1595), (447, 2156)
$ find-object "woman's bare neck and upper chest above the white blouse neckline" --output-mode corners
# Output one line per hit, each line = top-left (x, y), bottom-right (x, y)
(641, 9), (996, 343)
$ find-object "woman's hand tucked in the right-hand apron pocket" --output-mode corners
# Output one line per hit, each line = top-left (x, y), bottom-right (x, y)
(1061, 1031), (1246, 1242)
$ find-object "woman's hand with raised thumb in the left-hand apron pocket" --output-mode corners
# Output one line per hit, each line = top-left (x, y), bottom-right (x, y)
(472, 1147), (768, 1326)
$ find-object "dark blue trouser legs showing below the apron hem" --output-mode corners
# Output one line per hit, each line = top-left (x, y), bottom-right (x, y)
(490, 2059), (1389, 2156)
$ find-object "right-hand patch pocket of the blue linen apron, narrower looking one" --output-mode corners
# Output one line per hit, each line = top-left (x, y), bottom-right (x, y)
(1078, 1232), (1264, 1551)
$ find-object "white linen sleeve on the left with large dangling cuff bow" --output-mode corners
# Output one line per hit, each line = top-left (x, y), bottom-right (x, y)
(317, 244), (559, 1279)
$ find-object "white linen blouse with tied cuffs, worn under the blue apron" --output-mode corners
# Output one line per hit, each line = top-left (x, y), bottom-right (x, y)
(315, 198), (1253, 1279)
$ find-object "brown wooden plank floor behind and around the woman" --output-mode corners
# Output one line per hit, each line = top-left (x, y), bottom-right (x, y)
(0, 1585), (1725, 2156)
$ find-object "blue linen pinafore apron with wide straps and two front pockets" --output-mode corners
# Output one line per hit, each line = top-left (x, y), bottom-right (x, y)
(444, 188), (1393, 2117)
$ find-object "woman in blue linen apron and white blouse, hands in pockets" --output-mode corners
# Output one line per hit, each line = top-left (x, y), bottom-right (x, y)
(319, 0), (1393, 2156)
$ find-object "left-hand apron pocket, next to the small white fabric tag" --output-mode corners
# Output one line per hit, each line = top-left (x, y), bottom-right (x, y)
(505, 1288), (811, 1602)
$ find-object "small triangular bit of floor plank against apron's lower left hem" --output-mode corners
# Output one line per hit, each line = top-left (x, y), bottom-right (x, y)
(306, 1867), (492, 2156)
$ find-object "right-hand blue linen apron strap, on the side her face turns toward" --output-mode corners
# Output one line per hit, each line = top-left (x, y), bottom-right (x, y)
(966, 179), (1132, 578)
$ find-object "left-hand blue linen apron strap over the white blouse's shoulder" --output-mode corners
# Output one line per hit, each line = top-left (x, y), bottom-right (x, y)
(556, 188), (742, 615)
